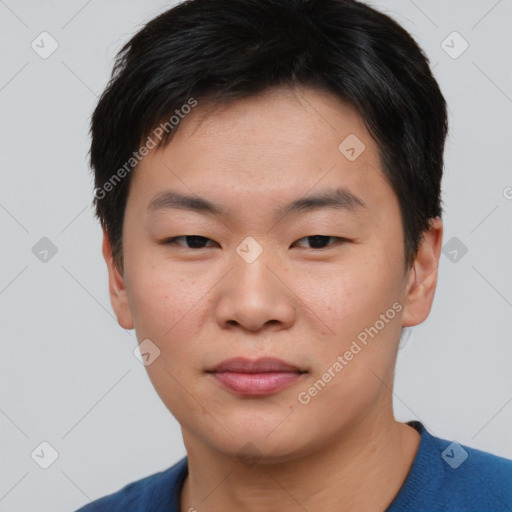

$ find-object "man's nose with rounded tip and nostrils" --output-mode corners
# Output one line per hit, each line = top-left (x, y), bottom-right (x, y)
(215, 244), (297, 331)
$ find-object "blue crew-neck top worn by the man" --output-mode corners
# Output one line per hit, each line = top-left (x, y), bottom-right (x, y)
(76, 421), (512, 512)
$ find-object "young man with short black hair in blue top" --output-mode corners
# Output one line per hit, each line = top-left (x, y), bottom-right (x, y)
(76, 0), (512, 512)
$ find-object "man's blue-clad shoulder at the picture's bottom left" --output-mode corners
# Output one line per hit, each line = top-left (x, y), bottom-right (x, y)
(76, 457), (188, 512)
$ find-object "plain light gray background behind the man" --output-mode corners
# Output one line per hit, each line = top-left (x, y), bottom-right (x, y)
(0, 0), (512, 512)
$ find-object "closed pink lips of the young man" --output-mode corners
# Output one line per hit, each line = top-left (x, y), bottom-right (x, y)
(207, 357), (307, 396)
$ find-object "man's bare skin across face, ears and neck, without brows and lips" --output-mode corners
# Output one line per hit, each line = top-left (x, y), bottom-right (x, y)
(103, 88), (443, 512)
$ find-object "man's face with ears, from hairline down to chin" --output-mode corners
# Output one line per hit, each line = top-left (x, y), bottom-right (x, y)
(104, 88), (439, 460)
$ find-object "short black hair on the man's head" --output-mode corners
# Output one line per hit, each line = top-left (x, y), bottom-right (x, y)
(90, 0), (448, 269)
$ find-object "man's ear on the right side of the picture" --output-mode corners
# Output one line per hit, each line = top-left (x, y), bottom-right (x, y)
(402, 217), (443, 327)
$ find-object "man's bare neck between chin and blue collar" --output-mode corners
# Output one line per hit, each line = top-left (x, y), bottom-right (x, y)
(180, 414), (420, 512)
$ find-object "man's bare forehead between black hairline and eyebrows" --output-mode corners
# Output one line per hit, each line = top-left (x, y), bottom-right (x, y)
(130, 88), (394, 217)
